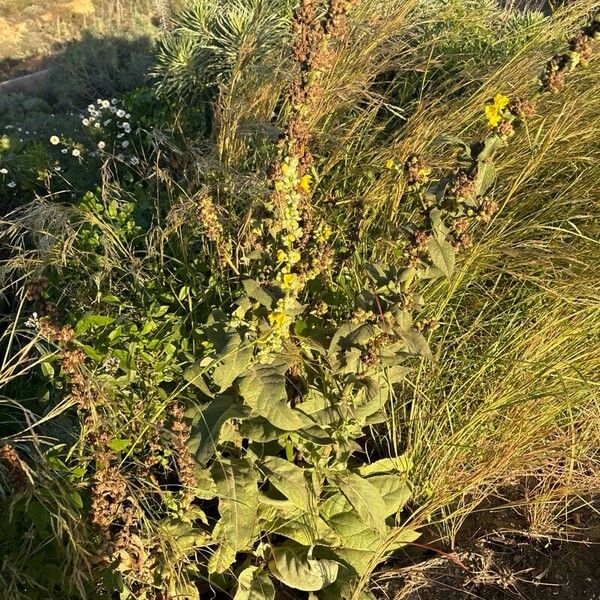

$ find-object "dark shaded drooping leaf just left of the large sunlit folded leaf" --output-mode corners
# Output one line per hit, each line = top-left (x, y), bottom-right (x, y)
(189, 396), (250, 465)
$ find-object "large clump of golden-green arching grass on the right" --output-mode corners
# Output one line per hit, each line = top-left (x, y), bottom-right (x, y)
(380, 23), (600, 544)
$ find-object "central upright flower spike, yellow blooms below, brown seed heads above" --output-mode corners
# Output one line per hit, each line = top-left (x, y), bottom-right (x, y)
(267, 0), (358, 349)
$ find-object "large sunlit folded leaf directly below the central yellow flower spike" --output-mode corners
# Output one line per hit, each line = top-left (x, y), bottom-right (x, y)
(239, 363), (309, 431)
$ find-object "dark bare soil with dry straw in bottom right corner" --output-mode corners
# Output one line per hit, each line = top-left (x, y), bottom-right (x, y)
(374, 504), (600, 600)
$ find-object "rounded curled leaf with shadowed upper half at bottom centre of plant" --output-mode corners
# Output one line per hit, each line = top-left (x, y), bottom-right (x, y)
(269, 542), (339, 592)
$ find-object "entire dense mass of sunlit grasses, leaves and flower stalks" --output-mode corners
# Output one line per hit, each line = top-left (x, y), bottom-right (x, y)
(0, 0), (600, 600)
